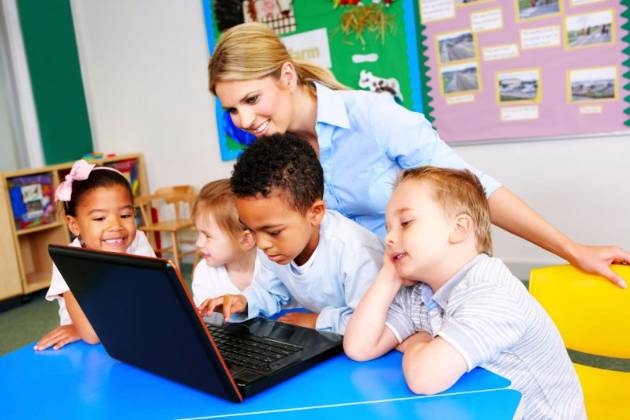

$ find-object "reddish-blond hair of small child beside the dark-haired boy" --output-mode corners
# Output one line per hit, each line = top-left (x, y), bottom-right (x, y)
(192, 179), (246, 241)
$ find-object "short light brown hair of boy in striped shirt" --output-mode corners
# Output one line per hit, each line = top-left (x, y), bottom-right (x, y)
(396, 166), (492, 255)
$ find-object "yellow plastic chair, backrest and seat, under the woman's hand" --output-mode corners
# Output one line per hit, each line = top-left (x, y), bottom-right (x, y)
(529, 265), (630, 420)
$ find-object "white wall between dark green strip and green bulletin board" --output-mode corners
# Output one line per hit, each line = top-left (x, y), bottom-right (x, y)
(72, 0), (232, 190)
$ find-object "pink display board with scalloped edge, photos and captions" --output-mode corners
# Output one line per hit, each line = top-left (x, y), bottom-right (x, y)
(419, 0), (629, 142)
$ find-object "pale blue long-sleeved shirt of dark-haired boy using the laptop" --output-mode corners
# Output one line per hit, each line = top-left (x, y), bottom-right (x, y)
(243, 210), (384, 334)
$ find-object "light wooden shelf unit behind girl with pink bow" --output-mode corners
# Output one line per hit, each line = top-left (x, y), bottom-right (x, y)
(0, 154), (149, 300)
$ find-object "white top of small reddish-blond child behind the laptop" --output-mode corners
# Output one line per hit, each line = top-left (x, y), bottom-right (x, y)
(192, 255), (261, 306)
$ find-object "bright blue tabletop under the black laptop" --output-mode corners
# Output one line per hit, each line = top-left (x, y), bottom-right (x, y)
(0, 343), (521, 420)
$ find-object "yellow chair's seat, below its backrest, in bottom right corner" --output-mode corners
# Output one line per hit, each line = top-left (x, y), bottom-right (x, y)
(574, 363), (630, 420)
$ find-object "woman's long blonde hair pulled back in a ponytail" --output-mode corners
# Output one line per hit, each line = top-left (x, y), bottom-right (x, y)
(208, 22), (348, 95)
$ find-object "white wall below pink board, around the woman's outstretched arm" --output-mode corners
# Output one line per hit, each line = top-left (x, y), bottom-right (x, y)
(456, 134), (630, 278)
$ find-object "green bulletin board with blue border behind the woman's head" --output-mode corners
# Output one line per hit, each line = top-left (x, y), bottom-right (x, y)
(202, 0), (428, 160)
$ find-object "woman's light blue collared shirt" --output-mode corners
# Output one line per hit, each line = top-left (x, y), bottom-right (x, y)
(315, 83), (501, 238)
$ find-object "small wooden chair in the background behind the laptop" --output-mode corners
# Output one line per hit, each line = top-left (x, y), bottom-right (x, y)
(135, 185), (196, 267)
